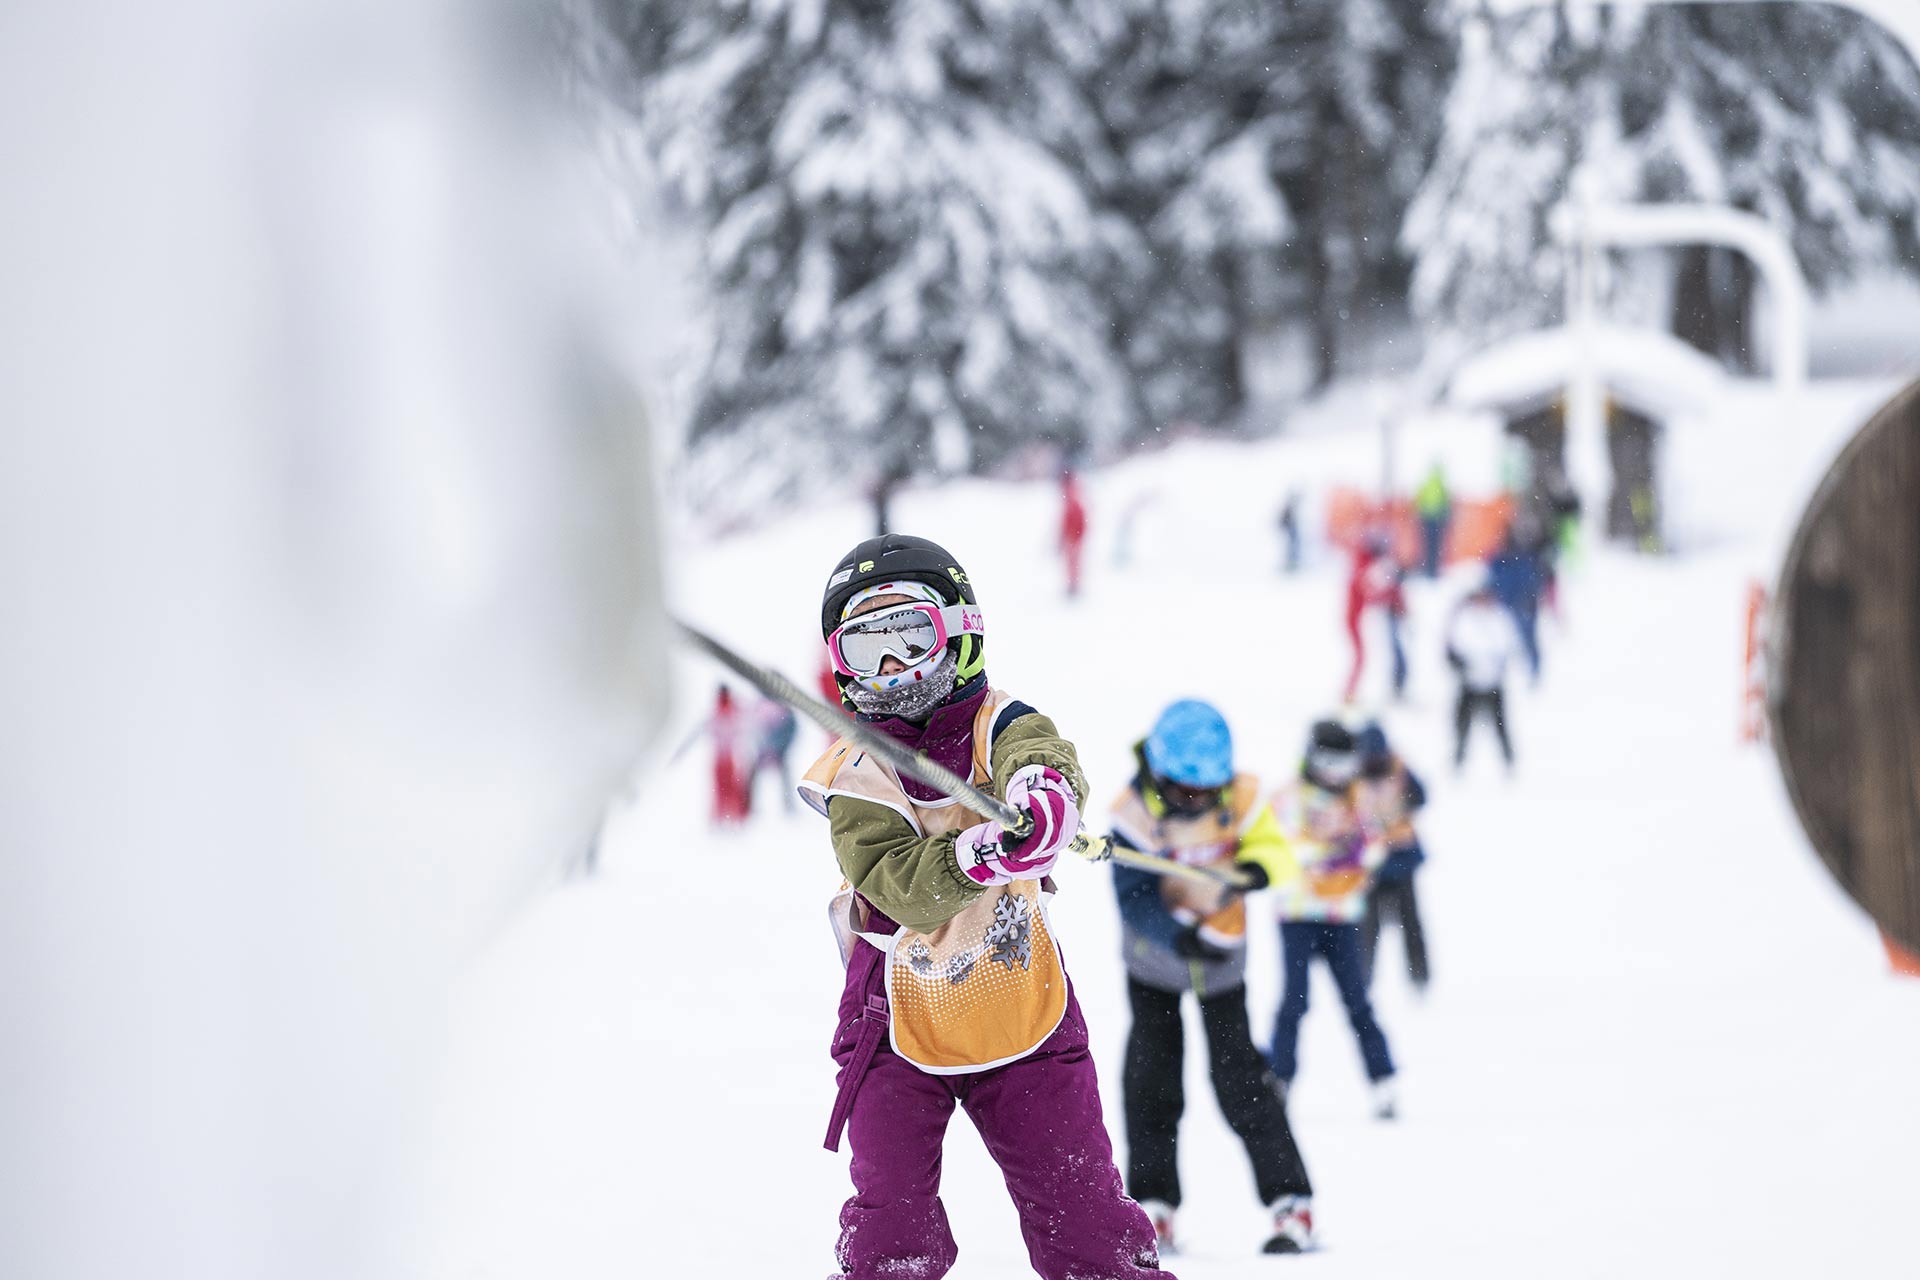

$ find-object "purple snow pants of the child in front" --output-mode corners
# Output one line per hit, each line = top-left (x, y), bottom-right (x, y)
(833, 942), (1175, 1280)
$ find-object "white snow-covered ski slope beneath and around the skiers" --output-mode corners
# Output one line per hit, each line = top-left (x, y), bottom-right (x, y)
(422, 384), (1920, 1280)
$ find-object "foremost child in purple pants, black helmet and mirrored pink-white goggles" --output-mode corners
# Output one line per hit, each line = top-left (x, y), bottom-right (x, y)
(801, 533), (1165, 1280)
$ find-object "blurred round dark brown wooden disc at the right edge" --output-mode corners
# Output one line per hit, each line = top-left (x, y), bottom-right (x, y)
(1768, 384), (1920, 952)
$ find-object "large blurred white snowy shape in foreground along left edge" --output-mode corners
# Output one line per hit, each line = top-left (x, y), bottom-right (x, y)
(0, 0), (664, 1280)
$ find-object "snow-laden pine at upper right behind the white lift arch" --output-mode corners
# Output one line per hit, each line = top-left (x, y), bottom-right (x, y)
(1404, 4), (1920, 361)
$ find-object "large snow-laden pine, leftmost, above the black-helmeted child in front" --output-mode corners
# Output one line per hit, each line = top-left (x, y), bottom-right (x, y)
(610, 0), (1127, 510)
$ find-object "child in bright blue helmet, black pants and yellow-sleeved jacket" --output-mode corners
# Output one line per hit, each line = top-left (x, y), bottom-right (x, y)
(1114, 700), (1313, 1253)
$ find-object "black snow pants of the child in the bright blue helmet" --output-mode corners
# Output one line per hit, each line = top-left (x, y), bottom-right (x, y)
(1119, 979), (1313, 1205)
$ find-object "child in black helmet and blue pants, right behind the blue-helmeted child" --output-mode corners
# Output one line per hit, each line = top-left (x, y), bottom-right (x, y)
(1271, 720), (1394, 1119)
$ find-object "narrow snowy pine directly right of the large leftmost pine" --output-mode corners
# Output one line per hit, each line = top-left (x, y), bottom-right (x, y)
(1046, 0), (1288, 436)
